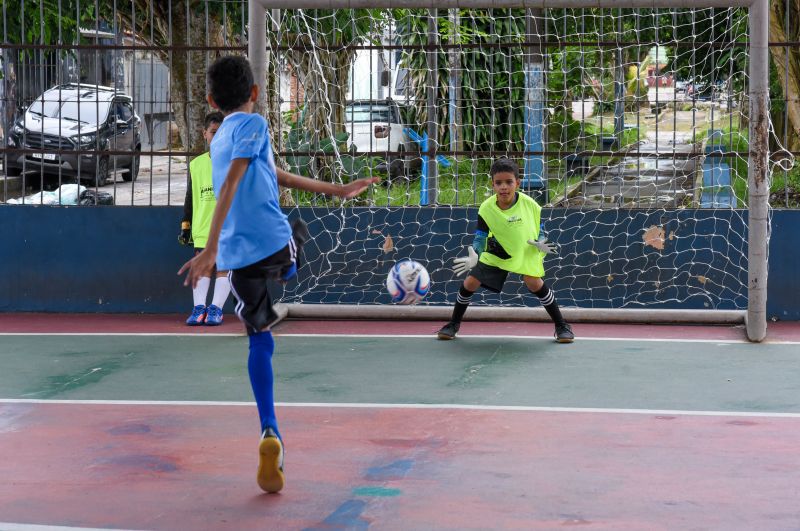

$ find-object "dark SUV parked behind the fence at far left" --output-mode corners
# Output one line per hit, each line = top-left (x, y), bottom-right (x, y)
(6, 84), (142, 186)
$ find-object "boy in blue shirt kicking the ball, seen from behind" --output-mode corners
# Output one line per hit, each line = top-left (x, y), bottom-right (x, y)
(178, 56), (378, 492)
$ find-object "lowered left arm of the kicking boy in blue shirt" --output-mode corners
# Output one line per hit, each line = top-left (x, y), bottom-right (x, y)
(178, 159), (250, 288)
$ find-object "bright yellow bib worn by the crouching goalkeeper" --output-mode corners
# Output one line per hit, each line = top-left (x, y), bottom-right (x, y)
(478, 193), (545, 278)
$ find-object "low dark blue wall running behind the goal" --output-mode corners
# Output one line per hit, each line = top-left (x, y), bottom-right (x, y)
(0, 206), (800, 320)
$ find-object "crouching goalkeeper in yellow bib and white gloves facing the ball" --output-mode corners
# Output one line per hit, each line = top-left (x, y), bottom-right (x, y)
(438, 158), (575, 343)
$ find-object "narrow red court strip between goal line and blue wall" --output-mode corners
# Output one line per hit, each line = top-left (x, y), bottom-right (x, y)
(0, 313), (800, 341)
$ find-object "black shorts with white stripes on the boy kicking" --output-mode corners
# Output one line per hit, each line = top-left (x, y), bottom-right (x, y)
(228, 220), (308, 334)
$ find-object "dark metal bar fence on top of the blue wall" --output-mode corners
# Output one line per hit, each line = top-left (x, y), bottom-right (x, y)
(0, 0), (800, 210)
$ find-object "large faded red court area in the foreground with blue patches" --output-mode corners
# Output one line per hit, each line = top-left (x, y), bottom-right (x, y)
(0, 402), (800, 530)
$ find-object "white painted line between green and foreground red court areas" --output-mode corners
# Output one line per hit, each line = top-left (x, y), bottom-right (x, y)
(0, 398), (800, 422)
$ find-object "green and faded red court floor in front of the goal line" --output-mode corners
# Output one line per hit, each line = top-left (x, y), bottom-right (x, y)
(0, 330), (800, 531)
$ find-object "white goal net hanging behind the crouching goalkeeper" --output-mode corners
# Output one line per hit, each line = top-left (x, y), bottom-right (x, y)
(260, 8), (777, 309)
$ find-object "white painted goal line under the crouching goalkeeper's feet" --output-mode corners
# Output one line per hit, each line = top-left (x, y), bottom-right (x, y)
(0, 332), (800, 345)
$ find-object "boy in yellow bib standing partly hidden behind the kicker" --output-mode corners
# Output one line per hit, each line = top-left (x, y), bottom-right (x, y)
(178, 111), (231, 326)
